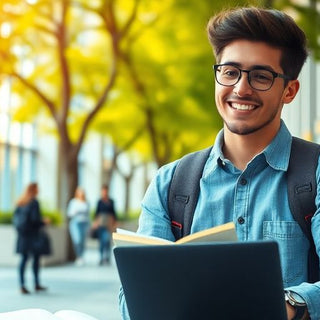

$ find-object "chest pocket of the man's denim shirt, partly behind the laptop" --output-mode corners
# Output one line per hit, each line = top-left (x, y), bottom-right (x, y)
(263, 221), (309, 287)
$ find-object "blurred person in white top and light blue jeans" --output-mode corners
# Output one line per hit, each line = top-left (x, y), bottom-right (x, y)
(67, 187), (90, 266)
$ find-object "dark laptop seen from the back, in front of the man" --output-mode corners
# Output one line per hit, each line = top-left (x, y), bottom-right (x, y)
(114, 241), (287, 320)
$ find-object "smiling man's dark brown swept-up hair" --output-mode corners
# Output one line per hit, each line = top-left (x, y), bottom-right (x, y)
(207, 7), (308, 79)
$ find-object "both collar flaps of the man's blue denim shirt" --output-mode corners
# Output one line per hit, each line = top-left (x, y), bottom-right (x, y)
(205, 120), (292, 174)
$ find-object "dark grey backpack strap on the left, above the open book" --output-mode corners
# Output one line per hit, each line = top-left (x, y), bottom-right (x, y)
(168, 147), (212, 240)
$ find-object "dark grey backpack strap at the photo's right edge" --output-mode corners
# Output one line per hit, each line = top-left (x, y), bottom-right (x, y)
(287, 137), (320, 282)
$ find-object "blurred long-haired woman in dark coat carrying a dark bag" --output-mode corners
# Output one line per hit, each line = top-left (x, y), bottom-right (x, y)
(13, 183), (51, 294)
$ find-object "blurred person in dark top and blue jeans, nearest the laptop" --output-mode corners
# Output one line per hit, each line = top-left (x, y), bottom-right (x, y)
(94, 185), (117, 265)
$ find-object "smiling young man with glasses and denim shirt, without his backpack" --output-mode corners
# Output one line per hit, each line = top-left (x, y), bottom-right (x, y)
(120, 8), (320, 320)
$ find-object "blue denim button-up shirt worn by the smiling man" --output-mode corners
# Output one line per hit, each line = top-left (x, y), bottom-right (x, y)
(120, 122), (320, 320)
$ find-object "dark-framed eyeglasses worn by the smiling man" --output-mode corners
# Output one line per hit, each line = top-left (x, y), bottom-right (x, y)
(213, 64), (290, 91)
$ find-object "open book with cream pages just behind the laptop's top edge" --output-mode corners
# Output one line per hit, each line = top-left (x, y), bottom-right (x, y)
(112, 222), (237, 246)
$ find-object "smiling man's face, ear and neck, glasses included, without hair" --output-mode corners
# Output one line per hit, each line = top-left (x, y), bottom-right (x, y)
(214, 39), (299, 170)
